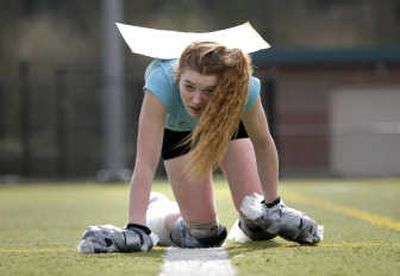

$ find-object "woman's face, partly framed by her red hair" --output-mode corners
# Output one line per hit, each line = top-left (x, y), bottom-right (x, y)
(179, 68), (217, 118)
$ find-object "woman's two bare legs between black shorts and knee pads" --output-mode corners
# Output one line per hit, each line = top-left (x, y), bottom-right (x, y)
(159, 139), (263, 226)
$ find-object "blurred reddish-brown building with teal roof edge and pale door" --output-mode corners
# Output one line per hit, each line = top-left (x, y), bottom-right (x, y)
(256, 49), (400, 177)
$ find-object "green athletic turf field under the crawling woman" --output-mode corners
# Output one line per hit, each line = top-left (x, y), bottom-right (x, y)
(0, 179), (400, 276)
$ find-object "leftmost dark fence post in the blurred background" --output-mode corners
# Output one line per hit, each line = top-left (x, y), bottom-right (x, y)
(19, 61), (32, 176)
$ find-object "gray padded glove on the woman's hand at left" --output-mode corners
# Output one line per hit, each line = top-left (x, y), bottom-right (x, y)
(78, 224), (155, 253)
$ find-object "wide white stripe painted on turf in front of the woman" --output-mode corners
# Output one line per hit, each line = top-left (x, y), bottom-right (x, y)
(160, 247), (236, 276)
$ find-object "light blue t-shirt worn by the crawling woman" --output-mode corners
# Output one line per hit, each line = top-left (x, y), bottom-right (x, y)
(143, 59), (261, 131)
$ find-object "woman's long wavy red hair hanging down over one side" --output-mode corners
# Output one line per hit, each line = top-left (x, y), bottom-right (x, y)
(177, 42), (252, 177)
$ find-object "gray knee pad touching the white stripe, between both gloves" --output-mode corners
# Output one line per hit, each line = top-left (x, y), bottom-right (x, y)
(170, 218), (227, 248)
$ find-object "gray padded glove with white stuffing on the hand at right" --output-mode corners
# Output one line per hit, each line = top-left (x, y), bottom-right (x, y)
(241, 197), (323, 244)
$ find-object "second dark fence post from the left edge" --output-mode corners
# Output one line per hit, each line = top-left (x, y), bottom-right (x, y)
(55, 69), (69, 178)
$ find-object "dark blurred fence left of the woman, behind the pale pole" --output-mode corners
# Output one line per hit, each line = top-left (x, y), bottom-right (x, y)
(0, 62), (143, 178)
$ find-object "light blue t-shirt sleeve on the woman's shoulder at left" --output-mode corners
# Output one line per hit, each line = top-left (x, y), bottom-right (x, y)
(143, 60), (173, 109)
